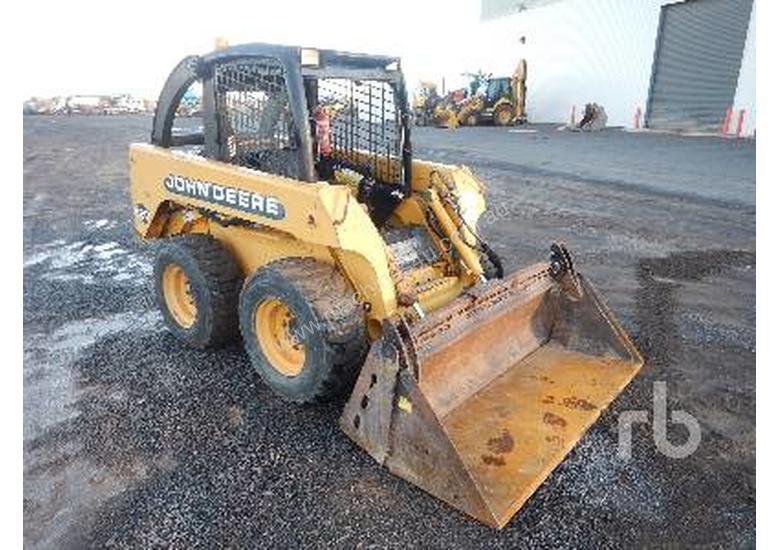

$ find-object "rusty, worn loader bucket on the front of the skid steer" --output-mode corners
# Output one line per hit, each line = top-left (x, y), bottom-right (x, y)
(341, 258), (642, 528)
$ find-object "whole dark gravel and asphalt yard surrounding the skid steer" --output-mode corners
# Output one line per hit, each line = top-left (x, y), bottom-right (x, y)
(24, 116), (755, 548)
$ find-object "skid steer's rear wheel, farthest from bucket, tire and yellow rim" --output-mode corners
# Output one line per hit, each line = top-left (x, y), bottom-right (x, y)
(154, 235), (242, 349)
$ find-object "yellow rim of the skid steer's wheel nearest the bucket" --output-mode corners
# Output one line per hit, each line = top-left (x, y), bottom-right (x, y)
(255, 298), (306, 377)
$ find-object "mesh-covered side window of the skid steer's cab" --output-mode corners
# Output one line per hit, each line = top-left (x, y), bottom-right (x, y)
(214, 57), (298, 177)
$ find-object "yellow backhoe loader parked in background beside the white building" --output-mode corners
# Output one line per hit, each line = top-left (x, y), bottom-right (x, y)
(436, 59), (527, 129)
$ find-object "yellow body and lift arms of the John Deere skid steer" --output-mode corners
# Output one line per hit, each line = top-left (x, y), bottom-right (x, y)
(130, 143), (485, 323)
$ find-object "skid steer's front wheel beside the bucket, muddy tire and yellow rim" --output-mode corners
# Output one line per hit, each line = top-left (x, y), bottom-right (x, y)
(239, 258), (368, 403)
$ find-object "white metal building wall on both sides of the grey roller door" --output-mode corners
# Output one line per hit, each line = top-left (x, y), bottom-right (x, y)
(476, 0), (755, 133)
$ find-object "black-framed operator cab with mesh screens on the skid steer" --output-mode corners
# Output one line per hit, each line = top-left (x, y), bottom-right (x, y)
(152, 44), (411, 226)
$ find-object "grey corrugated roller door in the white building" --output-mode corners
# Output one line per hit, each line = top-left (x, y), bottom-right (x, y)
(647, 0), (753, 132)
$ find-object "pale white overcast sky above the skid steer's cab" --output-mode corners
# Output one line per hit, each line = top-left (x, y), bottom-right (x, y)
(22, 0), (488, 99)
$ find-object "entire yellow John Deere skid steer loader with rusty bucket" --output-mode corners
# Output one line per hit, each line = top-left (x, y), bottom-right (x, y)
(129, 44), (642, 527)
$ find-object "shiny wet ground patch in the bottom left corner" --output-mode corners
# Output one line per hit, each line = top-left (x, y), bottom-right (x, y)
(23, 310), (175, 548)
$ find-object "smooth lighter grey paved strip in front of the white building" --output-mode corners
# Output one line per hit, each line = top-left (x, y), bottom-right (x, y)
(415, 124), (756, 206)
